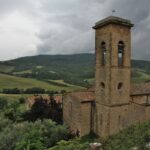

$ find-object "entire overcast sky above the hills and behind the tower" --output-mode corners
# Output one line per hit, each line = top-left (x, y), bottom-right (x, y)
(0, 0), (150, 61)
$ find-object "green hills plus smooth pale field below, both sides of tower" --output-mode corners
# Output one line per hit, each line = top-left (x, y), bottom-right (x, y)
(0, 54), (150, 90)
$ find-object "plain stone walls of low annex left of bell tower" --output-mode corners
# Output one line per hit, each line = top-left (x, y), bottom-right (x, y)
(63, 94), (92, 136)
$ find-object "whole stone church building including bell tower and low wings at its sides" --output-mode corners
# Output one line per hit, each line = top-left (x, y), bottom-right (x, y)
(63, 16), (150, 137)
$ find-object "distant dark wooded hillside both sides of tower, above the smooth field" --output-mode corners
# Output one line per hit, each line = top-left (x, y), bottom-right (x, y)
(0, 54), (150, 86)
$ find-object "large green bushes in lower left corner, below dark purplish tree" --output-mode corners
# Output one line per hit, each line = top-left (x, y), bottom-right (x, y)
(0, 94), (70, 150)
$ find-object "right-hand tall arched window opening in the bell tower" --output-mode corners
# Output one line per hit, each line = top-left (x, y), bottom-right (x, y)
(118, 41), (125, 66)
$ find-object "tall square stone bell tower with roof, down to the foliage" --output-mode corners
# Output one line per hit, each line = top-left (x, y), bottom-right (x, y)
(93, 16), (133, 137)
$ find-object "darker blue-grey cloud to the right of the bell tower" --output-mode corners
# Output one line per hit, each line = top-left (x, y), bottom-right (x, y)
(106, 0), (150, 60)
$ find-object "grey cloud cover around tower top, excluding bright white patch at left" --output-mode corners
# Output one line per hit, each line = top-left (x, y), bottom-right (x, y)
(0, 0), (150, 60)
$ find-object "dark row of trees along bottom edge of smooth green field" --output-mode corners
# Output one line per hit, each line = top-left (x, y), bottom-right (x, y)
(1, 87), (66, 94)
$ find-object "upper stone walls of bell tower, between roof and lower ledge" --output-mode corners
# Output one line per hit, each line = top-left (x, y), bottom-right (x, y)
(95, 24), (131, 105)
